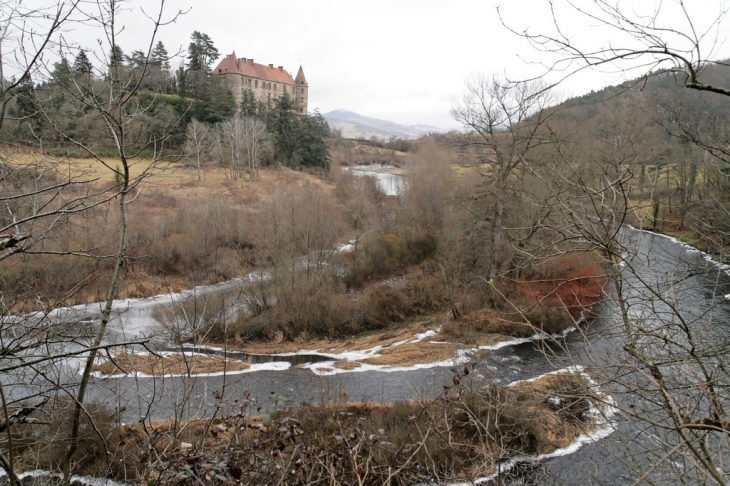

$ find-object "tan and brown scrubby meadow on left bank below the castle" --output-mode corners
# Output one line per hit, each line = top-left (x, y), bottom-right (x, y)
(0, 161), (331, 312)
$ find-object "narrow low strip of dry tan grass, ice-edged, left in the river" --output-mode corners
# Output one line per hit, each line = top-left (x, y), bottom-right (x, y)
(94, 352), (251, 376)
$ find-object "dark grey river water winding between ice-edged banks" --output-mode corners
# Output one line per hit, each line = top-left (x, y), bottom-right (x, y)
(4, 170), (730, 485)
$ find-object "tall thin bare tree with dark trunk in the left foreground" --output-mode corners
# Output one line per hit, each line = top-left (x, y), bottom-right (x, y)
(2, 0), (185, 484)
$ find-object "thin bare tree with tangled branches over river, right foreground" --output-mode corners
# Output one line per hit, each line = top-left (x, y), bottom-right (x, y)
(510, 86), (730, 484)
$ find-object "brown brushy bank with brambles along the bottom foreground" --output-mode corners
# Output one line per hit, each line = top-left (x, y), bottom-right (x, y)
(8, 367), (595, 484)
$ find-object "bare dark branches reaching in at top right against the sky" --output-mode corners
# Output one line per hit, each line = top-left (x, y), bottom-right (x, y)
(498, 0), (730, 96)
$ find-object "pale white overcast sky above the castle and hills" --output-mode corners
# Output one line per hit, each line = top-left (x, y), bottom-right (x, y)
(22, 0), (730, 128)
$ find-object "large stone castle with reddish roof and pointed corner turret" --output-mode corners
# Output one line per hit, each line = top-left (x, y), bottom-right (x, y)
(213, 51), (309, 115)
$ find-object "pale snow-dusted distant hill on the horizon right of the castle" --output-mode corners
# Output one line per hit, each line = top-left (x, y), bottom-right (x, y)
(322, 110), (444, 139)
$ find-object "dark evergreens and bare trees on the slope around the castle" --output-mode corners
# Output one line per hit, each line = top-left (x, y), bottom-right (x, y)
(1, 31), (330, 173)
